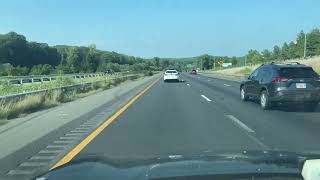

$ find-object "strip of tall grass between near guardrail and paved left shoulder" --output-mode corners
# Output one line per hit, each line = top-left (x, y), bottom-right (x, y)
(0, 75), (142, 121)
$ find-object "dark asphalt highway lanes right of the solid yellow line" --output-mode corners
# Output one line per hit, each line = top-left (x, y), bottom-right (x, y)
(3, 73), (320, 179)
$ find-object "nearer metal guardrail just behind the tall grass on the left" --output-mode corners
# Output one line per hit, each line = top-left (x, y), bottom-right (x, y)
(0, 75), (139, 102)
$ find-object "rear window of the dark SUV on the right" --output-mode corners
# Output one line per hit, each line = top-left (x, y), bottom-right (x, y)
(279, 67), (318, 78)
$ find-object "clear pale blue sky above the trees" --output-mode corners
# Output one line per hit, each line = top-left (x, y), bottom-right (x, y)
(0, 0), (320, 57)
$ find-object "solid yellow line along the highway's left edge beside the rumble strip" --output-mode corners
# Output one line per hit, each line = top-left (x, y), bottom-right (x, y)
(50, 79), (159, 170)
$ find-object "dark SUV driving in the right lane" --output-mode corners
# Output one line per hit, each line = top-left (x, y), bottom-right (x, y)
(240, 63), (320, 111)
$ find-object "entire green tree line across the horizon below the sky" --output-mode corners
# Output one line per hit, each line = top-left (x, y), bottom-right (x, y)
(0, 29), (320, 76)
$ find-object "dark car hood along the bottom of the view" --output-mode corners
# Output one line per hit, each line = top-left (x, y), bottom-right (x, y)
(35, 151), (320, 179)
